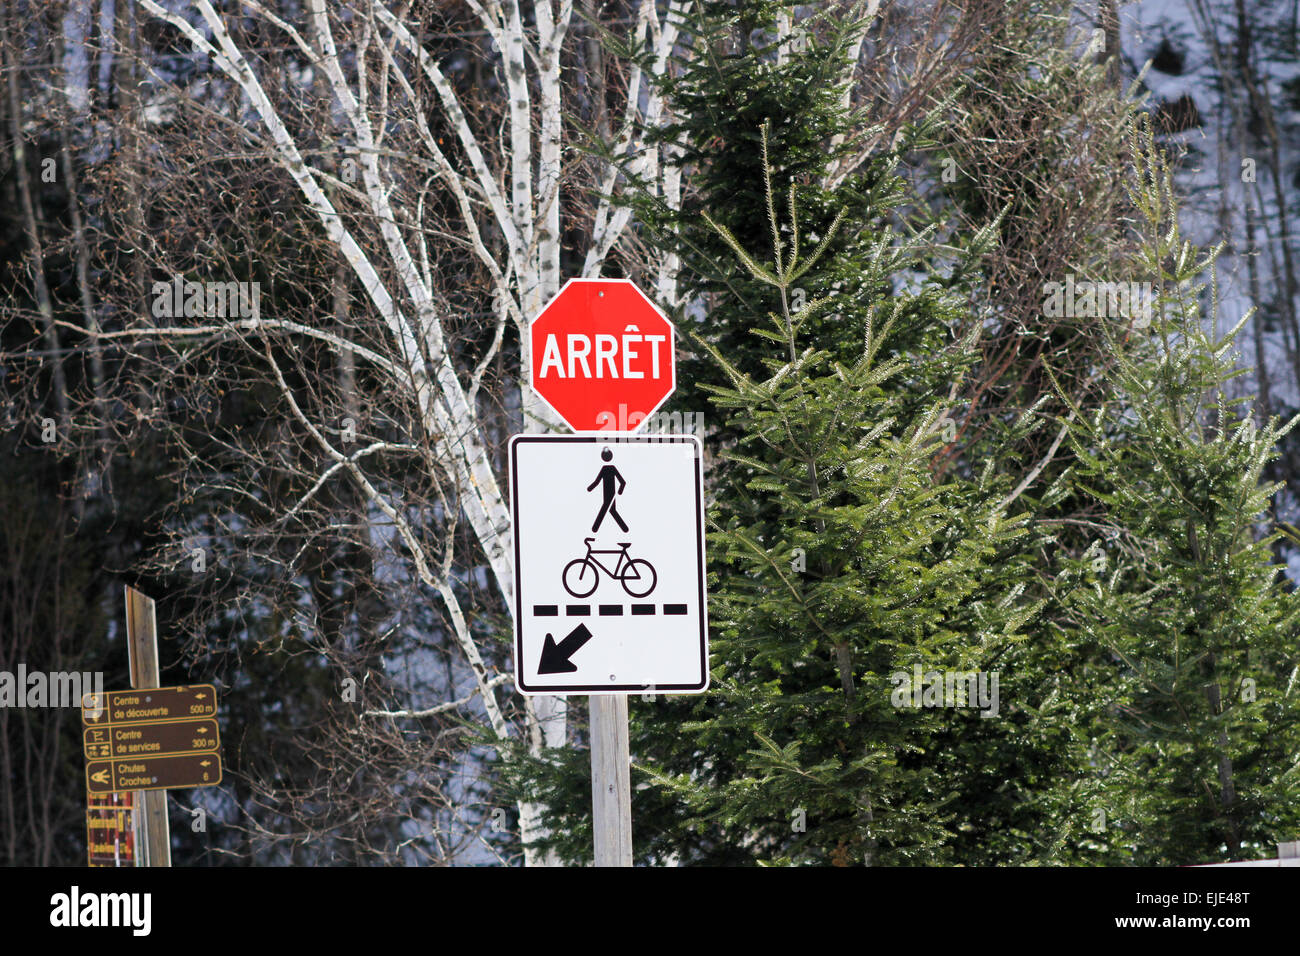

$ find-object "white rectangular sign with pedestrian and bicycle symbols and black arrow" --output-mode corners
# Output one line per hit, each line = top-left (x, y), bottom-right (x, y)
(510, 434), (709, 695)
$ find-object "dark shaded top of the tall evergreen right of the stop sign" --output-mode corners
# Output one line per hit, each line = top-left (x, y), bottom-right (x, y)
(618, 0), (952, 421)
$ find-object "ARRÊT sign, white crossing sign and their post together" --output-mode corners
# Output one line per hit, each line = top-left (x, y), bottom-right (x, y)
(510, 278), (709, 866)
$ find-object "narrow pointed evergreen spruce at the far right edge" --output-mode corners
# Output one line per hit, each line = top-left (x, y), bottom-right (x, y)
(1071, 115), (1300, 865)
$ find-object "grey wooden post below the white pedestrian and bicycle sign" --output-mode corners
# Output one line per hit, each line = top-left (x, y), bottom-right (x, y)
(588, 693), (632, 866)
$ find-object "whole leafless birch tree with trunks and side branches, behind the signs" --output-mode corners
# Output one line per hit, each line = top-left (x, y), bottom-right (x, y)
(77, 0), (680, 862)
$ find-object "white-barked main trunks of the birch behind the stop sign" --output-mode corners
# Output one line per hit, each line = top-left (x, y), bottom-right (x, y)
(135, 0), (684, 864)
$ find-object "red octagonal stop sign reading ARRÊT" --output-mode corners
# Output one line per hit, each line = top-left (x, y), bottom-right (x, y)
(529, 278), (677, 432)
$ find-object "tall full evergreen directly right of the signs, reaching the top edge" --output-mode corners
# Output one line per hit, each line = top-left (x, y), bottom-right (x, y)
(501, 3), (1102, 864)
